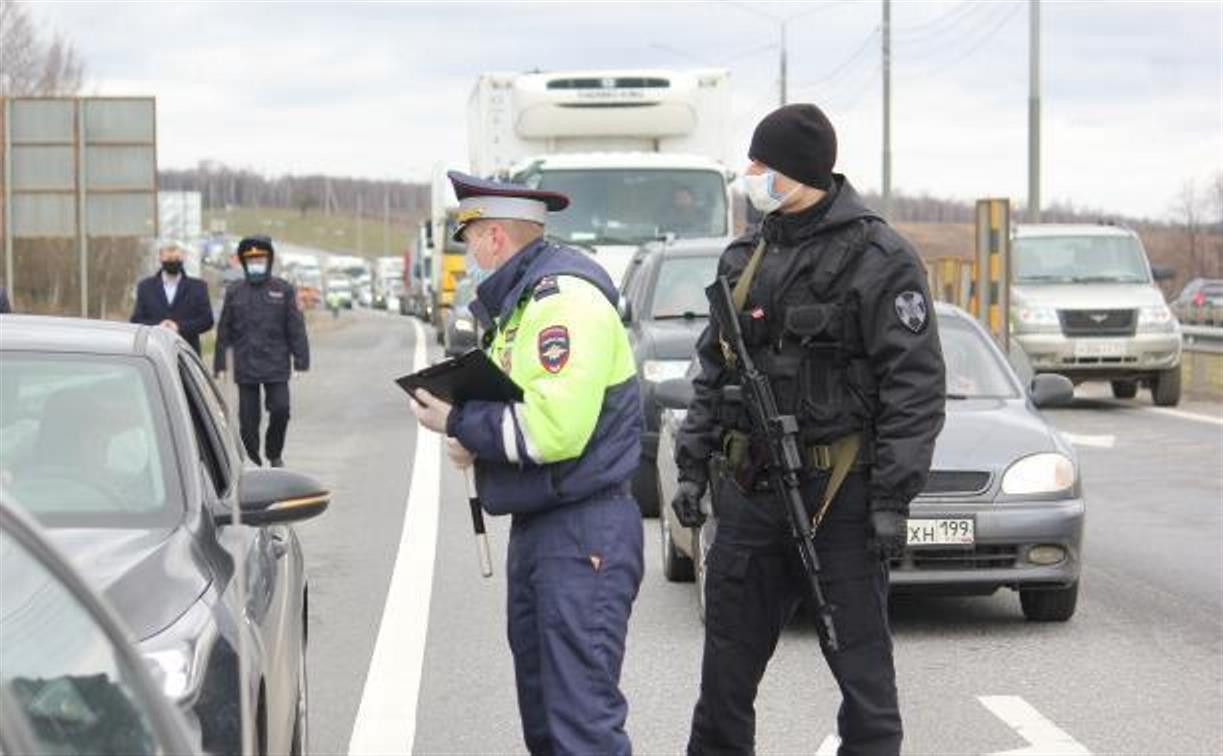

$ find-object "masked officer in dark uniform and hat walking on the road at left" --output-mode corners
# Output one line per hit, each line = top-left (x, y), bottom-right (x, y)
(213, 236), (309, 467)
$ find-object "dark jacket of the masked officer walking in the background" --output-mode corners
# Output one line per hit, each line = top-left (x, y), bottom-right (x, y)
(213, 276), (309, 383)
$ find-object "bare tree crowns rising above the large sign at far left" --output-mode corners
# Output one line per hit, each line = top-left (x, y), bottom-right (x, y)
(0, 0), (84, 97)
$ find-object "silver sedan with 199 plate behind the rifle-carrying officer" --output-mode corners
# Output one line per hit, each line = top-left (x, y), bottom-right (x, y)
(657, 305), (1086, 621)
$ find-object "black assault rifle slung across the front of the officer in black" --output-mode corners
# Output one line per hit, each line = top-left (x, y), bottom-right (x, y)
(704, 275), (838, 651)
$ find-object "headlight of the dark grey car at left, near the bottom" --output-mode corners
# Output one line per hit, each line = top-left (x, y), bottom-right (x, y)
(138, 602), (216, 703)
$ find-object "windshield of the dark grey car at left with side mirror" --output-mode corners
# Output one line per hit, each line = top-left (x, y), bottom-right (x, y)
(0, 354), (181, 526)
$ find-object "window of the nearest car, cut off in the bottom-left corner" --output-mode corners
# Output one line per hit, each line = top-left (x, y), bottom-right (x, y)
(0, 532), (161, 756)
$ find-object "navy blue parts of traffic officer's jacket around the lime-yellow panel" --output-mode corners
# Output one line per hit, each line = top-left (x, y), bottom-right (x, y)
(446, 240), (642, 515)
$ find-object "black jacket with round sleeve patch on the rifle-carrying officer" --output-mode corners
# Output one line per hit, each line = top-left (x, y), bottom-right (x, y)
(675, 174), (945, 511)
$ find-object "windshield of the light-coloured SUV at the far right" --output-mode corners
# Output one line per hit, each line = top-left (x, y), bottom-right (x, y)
(1011, 235), (1151, 284)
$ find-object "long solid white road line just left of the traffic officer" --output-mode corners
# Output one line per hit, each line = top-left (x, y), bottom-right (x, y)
(349, 321), (442, 755)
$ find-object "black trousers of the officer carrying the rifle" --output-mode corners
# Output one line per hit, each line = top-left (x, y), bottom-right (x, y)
(687, 473), (901, 756)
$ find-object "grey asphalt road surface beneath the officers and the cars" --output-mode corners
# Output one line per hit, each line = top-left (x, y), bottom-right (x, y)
(285, 311), (1223, 754)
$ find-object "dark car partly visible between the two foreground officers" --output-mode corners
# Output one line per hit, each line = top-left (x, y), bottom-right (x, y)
(620, 239), (730, 516)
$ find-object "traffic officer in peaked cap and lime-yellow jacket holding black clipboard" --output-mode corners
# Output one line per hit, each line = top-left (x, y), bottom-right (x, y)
(413, 172), (642, 755)
